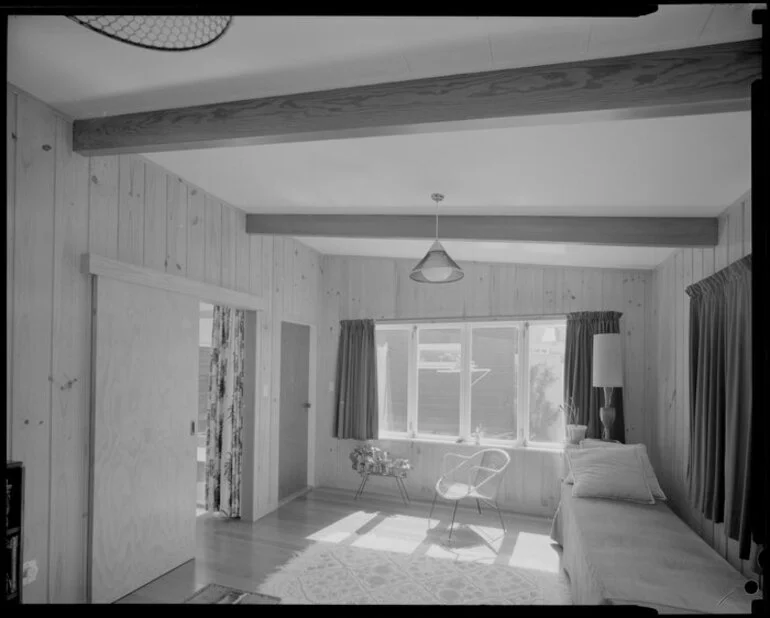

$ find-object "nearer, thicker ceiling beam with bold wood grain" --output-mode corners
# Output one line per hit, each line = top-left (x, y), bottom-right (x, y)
(73, 40), (760, 155)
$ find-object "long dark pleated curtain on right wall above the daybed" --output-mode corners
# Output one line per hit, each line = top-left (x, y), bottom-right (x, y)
(687, 256), (752, 559)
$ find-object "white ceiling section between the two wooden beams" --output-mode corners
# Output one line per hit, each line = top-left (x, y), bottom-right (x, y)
(147, 112), (751, 216)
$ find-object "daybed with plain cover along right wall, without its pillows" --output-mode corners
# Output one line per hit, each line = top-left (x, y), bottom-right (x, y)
(551, 483), (751, 613)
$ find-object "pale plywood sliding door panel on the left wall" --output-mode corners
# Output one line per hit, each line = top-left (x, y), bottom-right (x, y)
(89, 277), (199, 603)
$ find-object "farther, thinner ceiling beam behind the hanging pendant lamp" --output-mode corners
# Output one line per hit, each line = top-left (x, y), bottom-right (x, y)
(246, 214), (718, 247)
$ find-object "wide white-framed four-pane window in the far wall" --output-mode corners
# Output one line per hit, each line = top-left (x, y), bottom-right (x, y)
(376, 319), (566, 443)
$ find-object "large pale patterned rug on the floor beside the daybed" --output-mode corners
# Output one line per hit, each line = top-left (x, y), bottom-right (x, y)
(259, 543), (572, 605)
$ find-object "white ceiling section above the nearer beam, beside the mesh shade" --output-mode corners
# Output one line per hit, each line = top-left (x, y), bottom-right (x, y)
(8, 4), (761, 118)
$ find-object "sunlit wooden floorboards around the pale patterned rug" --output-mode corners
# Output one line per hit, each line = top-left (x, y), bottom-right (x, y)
(119, 489), (560, 603)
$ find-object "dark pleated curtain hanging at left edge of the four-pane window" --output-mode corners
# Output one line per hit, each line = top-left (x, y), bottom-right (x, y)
(334, 320), (378, 440)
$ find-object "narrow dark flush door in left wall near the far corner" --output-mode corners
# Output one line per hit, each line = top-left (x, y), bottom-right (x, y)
(278, 322), (310, 500)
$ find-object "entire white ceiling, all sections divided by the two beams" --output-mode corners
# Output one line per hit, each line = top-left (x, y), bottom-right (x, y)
(8, 4), (761, 268)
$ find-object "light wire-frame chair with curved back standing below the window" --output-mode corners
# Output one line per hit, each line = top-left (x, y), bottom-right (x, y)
(428, 448), (511, 539)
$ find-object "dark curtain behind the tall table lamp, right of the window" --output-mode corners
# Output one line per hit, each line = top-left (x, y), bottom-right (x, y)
(564, 311), (626, 442)
